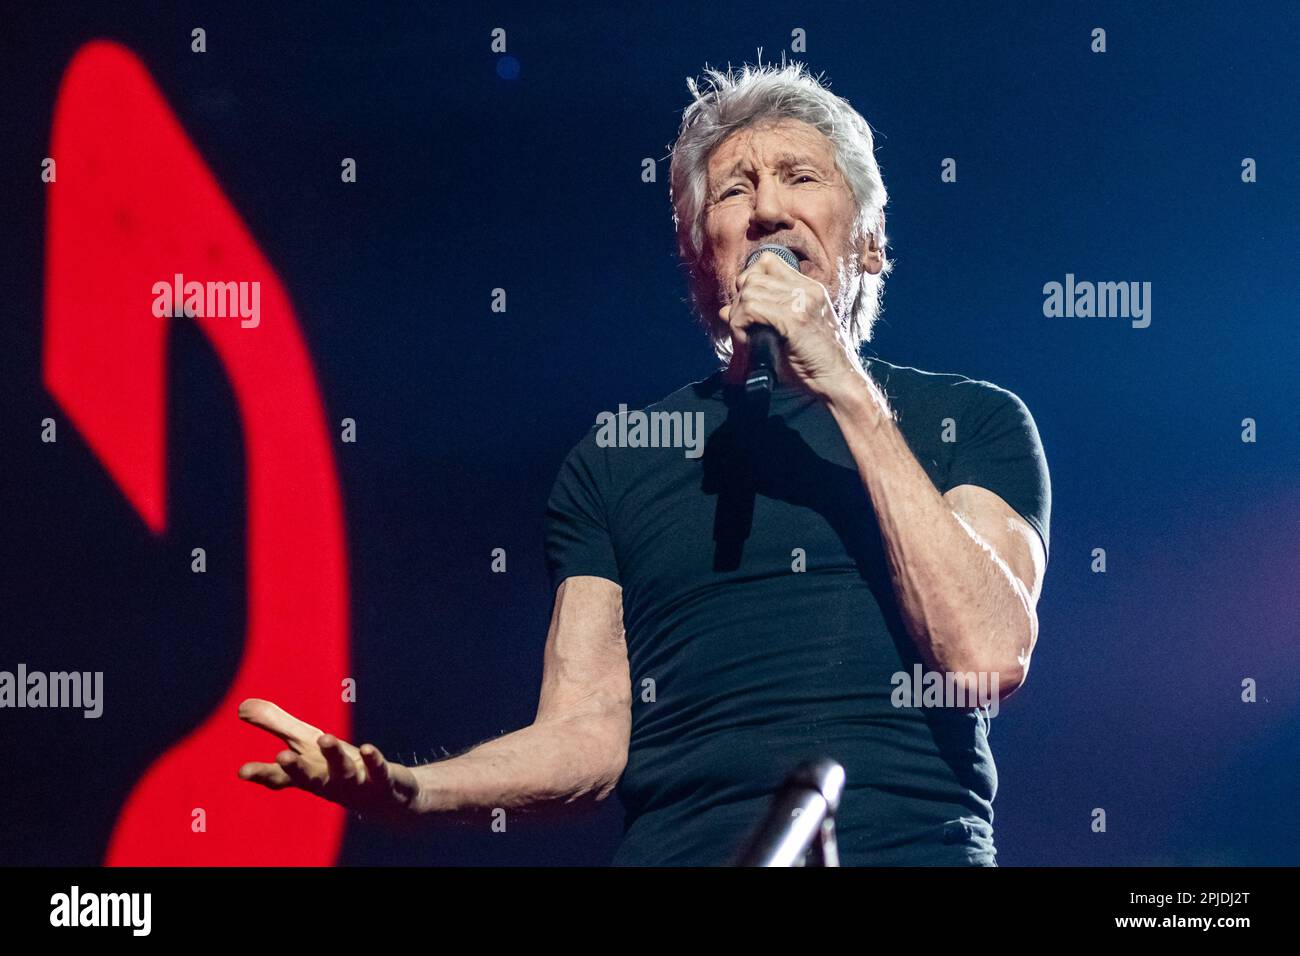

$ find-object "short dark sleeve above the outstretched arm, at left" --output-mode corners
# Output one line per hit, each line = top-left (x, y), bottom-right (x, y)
(546, 429), (619, 592)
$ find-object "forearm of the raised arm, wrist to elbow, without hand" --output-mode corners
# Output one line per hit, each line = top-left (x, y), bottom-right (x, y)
(826, 375), (1032, 695)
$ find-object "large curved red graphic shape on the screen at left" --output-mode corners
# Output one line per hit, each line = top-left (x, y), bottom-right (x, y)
(44, 40), (351, 866)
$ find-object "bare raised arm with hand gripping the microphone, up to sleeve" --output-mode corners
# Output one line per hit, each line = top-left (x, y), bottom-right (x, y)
(718, 252), (1047, 697)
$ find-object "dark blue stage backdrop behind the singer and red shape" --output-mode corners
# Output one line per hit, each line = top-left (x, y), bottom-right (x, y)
(0, 0), (1300, 865)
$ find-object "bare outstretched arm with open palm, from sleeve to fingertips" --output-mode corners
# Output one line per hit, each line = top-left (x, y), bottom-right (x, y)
(239, 576), (632, 822)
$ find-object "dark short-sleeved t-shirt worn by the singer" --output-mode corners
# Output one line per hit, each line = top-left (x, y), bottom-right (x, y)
(546, 359), (1050, 865)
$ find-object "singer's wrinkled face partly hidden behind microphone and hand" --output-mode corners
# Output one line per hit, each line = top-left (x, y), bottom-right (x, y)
(705, 120), (881, 316)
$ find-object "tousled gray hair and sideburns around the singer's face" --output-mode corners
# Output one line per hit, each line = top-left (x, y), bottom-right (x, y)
(668, 62), (893, 362)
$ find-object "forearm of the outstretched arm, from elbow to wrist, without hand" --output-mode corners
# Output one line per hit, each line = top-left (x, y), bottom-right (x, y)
(412, 718), (623, 822)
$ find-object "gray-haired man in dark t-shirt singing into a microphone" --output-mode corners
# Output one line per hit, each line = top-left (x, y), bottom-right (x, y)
(239, 64), (1050, 866)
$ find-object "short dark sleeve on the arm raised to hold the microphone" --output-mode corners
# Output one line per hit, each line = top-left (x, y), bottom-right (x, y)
(943, 382), (1052, 555)
